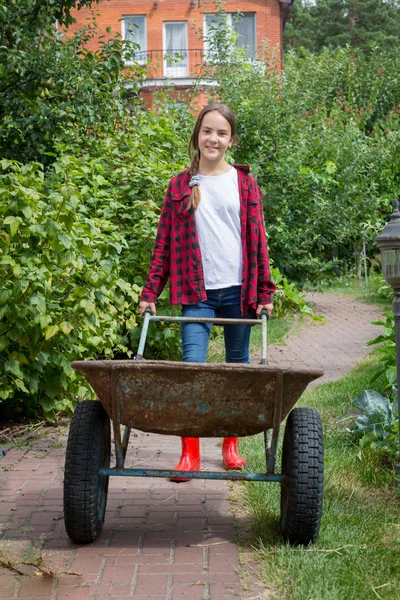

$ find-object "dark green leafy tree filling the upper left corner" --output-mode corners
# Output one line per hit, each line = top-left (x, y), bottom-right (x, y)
(0, 0), (143, 164)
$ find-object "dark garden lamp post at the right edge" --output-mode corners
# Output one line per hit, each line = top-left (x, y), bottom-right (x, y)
(376, 200), (400, 486)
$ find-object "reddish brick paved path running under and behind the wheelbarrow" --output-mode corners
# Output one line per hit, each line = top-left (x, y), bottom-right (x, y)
(0, 294), (380, 600)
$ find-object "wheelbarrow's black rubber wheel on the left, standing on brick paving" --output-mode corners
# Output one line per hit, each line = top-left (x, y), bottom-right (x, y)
(64, 401), (111, 544)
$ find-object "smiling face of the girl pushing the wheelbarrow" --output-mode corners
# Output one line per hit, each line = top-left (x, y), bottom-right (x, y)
(198, 110), (233, 164)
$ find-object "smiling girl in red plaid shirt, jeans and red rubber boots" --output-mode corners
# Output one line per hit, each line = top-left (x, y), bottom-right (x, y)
(140, 104), (275, 481)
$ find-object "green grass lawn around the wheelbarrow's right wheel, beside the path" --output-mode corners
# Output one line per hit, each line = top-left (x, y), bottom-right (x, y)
(237, 355), (400, 600)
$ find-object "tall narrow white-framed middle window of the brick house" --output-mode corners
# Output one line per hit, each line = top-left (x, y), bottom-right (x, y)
(163, 21), (189, 77)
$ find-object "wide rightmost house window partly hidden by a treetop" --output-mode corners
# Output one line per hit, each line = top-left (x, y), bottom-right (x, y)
(204, 13), (256, 59)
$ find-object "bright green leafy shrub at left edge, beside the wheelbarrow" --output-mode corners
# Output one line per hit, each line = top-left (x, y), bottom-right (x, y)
(0, 160), (139, 414)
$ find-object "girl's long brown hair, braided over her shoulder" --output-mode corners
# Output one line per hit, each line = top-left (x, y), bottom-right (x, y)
(187, 102), (237, 210)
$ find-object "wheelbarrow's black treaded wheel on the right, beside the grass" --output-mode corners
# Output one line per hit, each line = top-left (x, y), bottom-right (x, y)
(281, 408), (324, 545)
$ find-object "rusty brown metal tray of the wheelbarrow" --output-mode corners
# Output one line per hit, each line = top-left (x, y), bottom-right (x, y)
(72, 360), (323, 437)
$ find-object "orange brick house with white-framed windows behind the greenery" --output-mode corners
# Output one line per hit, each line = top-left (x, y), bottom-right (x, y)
(69, 0), (293, 104)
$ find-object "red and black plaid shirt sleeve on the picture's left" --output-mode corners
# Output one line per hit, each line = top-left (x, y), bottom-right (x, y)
(140, 182), (172, 302)
